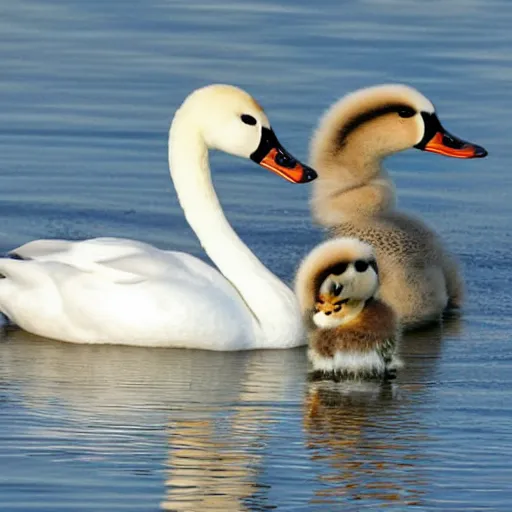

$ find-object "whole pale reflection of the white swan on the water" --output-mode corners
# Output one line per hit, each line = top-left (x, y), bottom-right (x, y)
(0, 331), (306, 511)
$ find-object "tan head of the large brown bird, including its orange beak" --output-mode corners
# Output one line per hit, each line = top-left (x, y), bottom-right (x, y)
(311, 84), (487, 170)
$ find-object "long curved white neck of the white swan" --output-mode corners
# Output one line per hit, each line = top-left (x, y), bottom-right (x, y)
(169, 112), (303, 348)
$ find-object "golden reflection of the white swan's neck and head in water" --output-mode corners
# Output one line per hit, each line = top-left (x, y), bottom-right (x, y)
(162, 349), (306, 511)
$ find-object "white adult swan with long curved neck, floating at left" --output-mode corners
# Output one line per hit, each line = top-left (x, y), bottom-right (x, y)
(0, 85), (316, 350)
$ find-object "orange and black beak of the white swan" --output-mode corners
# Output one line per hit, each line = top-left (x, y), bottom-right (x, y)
(251, 128), (317, 183)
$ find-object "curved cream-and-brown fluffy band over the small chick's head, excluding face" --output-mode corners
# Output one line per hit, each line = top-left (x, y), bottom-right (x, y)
(295, 237), (374, 314)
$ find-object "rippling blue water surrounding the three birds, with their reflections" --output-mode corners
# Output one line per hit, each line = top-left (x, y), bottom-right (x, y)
(0, 0), (512, 512)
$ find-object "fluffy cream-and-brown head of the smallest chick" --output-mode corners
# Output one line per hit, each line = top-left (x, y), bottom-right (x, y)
(295, 237), (379, 312)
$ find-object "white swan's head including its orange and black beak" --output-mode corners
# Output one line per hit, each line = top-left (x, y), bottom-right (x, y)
(171, 84), (317, 183)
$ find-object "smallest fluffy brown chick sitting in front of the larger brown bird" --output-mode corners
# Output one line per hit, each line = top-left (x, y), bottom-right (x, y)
(295, 238), (400, 380)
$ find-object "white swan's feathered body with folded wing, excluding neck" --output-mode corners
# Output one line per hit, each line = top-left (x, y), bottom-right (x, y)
(0, 239), (257, 350)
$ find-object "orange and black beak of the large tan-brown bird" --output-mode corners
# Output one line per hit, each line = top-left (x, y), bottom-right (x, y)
(414, 112), (487, 158)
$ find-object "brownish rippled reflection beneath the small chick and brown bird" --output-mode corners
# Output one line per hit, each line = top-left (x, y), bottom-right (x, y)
(304, 318), (460, 507)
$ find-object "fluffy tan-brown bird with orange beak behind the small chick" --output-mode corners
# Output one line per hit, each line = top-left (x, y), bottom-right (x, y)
(311, 85), (487, 329)
